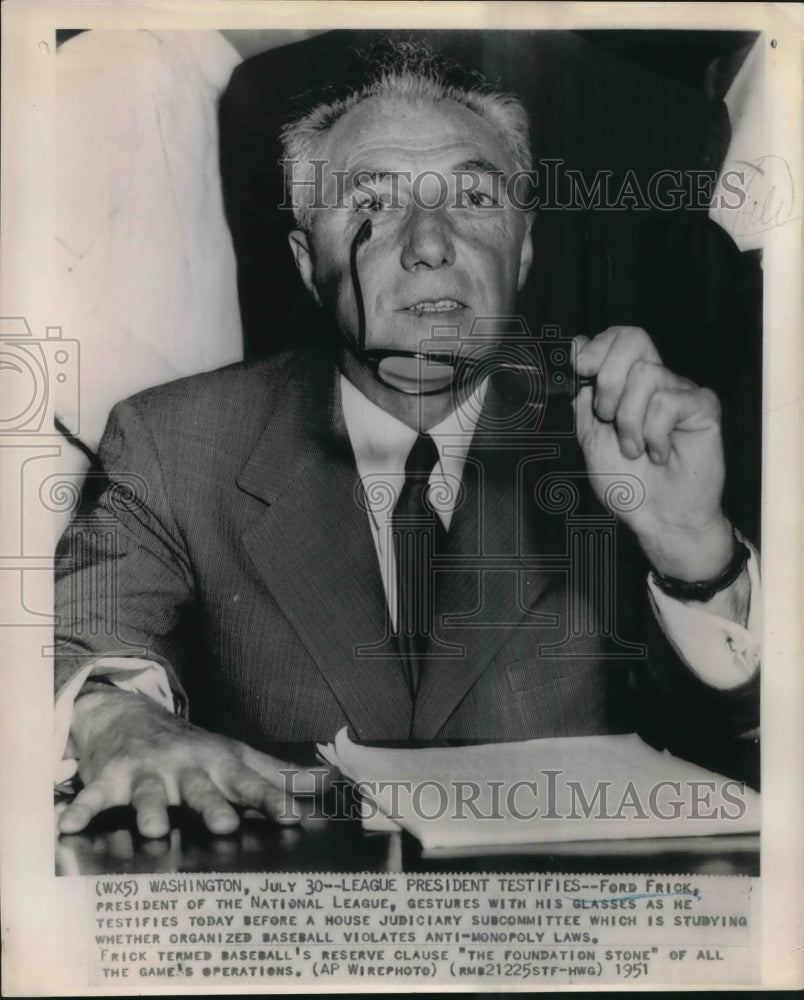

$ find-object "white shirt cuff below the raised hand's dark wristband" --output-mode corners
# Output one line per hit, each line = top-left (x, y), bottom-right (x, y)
(648, 542), (762, 690)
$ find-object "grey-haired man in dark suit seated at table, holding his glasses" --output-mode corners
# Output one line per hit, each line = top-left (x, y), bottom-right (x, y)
(57, 53), (758, 836)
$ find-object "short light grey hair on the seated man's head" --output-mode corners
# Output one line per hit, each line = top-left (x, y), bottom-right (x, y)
(280, 42), (532, 229)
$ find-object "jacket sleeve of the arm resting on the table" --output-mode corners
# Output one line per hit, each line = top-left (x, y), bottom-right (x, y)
(55, 401), (194, 704)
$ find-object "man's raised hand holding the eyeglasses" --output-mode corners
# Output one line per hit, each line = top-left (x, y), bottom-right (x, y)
(573, 326), (733, 581)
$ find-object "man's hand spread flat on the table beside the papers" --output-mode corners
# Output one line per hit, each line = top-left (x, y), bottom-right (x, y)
(59, 687), (322, 837)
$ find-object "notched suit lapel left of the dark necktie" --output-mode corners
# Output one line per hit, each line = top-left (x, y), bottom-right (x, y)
(238, 363), (411, 739)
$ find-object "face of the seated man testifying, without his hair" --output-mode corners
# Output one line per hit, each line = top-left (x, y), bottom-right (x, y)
(291, 98), (532, 406)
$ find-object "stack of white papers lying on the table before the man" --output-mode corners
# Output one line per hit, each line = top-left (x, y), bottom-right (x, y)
(319, 729), (760, 850)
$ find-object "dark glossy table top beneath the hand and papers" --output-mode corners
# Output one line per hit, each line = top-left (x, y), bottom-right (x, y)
(56, 803), (759, 875)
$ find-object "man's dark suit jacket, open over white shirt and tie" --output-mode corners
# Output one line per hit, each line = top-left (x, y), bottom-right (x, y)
(56, 352), (757, 760)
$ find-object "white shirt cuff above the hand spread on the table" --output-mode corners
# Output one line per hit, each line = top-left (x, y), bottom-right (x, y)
(53, 656), (176, 786)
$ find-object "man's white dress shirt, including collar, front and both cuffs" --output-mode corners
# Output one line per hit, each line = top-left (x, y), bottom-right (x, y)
(55, 376), (762, 783)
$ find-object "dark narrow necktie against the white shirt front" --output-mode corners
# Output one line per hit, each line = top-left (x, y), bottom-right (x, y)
(391, 434), (446, 694)
